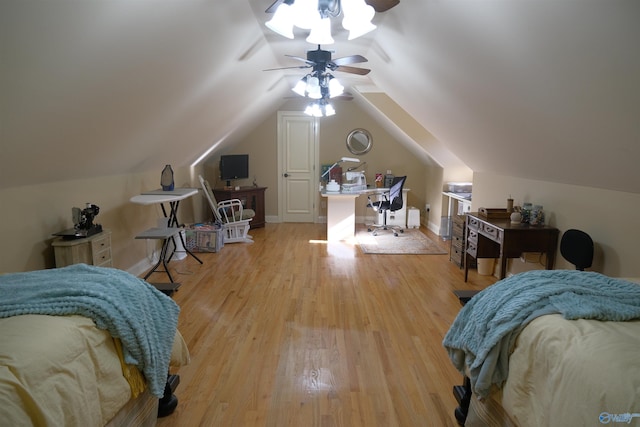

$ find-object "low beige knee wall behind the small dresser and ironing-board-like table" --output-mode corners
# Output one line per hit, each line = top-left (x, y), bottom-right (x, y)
(0, 165), (203, 274)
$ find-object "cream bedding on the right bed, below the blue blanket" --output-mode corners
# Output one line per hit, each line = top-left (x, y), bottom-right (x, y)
(502, 314), (640, 427)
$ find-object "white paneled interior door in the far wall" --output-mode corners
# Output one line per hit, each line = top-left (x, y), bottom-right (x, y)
(278, 111), (318, 222)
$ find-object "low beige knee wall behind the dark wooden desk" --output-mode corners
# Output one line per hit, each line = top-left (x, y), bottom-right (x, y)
(472, 172), (640, 277)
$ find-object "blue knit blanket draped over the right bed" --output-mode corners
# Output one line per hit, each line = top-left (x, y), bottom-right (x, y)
(443, 270), (640, 397)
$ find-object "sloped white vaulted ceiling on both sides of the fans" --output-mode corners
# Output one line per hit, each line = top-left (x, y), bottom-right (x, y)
(0, 0), (640, 193)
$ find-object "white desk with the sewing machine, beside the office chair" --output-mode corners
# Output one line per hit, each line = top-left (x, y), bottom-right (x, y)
(320, 188), (409, 242)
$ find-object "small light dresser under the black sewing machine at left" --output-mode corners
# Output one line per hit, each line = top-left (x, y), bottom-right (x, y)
(51, 230), (113, 268)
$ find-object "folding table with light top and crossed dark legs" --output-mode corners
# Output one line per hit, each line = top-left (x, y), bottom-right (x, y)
(129, 188), (202, 282)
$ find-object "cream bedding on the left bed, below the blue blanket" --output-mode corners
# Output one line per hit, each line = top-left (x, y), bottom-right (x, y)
(0, 315), (189, 426)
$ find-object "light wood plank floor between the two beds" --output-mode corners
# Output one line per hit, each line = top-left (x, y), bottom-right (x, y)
(155, 224), (495, 427)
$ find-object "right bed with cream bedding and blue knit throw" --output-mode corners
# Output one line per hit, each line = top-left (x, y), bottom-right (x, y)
(443, 270), (640, 427)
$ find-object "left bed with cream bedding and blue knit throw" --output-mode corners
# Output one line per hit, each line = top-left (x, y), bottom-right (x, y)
(0, 264), (189, 426)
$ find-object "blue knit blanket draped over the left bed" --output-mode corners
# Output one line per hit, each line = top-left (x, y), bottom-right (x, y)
(0, 264), (180, 397)
